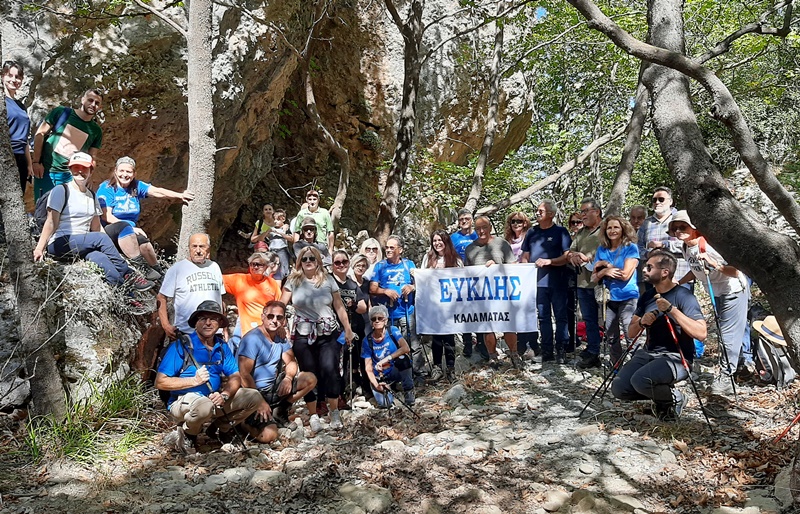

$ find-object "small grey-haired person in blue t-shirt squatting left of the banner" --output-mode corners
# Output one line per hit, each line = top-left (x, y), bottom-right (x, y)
(361, 305), (415, 408)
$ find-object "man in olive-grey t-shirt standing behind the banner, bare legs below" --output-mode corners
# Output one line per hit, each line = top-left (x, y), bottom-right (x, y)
(465, 216), (522, 369)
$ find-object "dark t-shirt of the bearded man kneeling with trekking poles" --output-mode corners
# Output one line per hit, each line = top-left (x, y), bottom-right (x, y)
(634, 285), (705, 362)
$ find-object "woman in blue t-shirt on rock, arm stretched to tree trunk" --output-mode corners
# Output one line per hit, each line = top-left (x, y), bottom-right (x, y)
(97, 157), (194, 280)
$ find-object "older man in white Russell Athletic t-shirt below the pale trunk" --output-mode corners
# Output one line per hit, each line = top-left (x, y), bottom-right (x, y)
(158, 234), (225, 340)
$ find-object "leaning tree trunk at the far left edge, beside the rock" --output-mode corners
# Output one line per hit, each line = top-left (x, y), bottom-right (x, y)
(0, 34), (66, 419)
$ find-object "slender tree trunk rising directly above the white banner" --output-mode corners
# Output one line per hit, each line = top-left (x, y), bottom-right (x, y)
(464, 2), (507, 212)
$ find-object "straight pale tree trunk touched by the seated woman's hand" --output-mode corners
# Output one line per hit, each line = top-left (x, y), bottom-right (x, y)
(178, 0), (217, 255)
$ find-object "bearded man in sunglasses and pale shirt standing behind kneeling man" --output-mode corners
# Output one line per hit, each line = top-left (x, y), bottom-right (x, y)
(637, 186), (694, 291)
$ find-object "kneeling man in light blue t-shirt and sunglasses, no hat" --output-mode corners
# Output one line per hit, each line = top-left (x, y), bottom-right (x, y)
(238, 300), (317, 443)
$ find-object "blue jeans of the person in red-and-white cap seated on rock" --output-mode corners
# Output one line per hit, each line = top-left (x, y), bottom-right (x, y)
(47, 232), (131, 285)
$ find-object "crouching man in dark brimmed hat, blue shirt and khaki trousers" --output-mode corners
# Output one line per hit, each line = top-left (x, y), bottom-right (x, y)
(155, 300), (261, 453)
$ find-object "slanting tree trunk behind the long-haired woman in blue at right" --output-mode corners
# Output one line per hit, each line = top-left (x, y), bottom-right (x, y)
(604, 63), (650, 216)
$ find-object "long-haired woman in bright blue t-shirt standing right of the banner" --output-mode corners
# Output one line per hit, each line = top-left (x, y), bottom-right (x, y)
(592, 216), (639, 365)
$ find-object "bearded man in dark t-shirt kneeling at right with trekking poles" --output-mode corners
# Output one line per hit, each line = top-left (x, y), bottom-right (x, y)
(611, 250), (706, 420)
